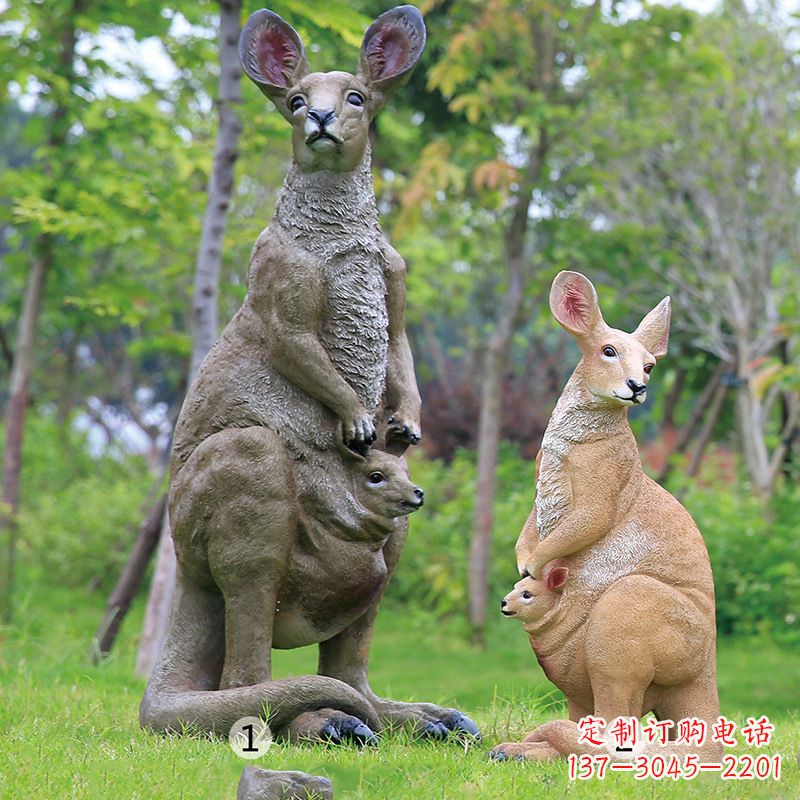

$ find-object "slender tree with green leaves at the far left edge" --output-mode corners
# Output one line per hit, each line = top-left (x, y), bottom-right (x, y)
(0, 0), (183, 619)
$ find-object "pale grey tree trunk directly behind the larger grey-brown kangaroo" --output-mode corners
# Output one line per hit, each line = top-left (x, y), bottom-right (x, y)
(136, 0), (242, 676)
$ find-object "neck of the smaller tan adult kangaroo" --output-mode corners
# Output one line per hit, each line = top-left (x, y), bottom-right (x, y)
(542, 361), (633, 450)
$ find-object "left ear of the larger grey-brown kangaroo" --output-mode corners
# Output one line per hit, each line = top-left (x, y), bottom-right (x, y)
(239, 8), (308, 120)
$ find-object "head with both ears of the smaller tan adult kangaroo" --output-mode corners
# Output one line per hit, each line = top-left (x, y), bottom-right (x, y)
(550, 270), (670, 405)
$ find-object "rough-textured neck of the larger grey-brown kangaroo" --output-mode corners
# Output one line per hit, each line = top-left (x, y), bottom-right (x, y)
(275, 150), (381, 256)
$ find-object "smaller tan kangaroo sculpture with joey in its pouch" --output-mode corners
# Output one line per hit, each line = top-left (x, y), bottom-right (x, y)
(492, 272), (720, 760)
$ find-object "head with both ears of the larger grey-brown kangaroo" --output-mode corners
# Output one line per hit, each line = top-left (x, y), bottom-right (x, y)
(239, 6), (425, 172)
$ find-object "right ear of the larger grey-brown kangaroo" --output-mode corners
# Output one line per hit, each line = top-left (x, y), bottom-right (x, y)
(358, 6), (426, 115)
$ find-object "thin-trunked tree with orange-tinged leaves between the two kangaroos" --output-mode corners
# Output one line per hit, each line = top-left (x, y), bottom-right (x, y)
(407, 0), (700, 642)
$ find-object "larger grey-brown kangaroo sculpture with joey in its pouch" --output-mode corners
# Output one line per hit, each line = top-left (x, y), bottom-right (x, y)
(140, 6), (477, 742)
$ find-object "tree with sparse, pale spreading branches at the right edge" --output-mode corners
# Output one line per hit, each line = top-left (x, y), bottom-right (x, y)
(592, 3), (800, 499)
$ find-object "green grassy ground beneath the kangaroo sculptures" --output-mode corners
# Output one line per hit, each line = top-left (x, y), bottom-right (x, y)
(0, 587), (800, 800)
